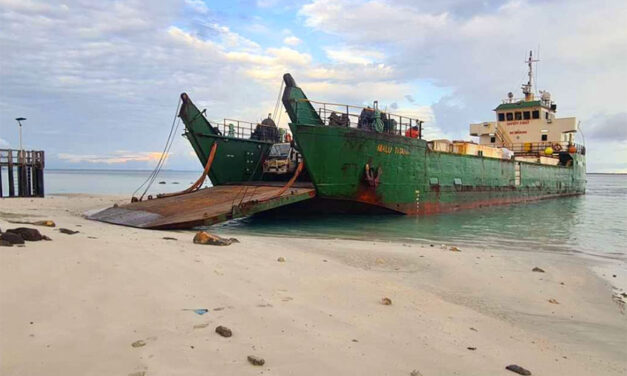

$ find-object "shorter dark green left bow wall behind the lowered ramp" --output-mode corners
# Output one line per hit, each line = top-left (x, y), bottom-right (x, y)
(179, 93), (272, 186)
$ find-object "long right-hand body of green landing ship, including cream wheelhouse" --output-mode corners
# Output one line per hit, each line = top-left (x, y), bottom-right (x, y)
(282, 54), (586, 215)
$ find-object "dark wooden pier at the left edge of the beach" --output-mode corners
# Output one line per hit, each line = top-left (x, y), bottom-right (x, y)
(0, 149), (45, 197)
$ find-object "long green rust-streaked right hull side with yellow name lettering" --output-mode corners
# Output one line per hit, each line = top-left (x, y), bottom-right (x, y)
(283, 75), (586, 214)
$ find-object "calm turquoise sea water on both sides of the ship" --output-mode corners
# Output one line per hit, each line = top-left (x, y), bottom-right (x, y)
(41, 170), (627, 260)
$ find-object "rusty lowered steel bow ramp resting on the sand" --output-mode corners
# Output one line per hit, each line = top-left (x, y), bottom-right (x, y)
(87, 183), (316, 229)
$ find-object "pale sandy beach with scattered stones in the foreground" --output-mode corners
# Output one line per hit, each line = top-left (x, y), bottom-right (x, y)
(0, 195), (627, 376)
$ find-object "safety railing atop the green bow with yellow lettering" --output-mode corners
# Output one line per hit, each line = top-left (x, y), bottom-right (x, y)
(297, 99), (423, 138)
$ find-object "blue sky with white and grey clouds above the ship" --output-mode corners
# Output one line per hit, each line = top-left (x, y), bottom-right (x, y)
(0, 0), (627, 173)
